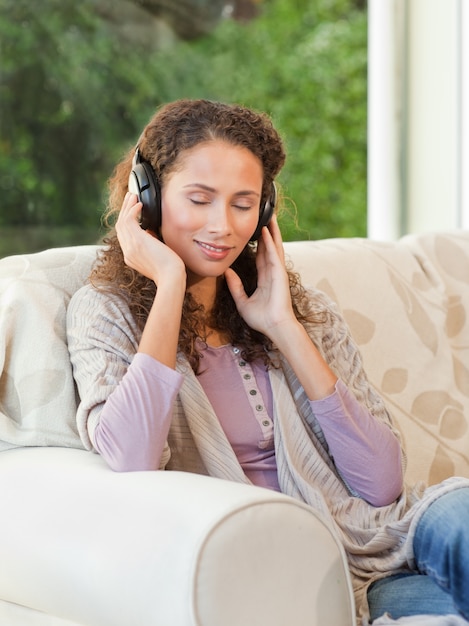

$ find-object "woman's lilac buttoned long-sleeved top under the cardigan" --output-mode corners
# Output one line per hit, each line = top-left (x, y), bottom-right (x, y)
(94, 346), (401, 503)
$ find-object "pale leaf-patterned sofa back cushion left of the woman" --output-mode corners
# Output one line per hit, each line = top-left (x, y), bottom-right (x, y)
(0, 246), (96, 450)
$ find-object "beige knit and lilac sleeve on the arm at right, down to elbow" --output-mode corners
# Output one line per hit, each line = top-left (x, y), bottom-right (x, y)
(307, 291), (406, 506)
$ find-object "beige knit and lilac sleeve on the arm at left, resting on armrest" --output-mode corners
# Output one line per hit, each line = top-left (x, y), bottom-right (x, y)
(67, 285), (182, 471)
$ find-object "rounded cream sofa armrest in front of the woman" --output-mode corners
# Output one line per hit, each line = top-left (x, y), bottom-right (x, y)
(0, 448), (354, 626)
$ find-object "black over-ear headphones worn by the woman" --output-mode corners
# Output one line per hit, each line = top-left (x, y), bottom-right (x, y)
(129, 148), (277, 241)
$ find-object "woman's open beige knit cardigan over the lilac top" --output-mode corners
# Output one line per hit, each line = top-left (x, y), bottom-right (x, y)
(68, 286), (469, 621)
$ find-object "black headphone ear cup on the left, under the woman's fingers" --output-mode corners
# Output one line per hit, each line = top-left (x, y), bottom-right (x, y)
(129, 161), (161, 233)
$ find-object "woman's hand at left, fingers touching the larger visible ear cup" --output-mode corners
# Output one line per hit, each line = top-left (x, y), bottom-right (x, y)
(116, 192), (186, 285)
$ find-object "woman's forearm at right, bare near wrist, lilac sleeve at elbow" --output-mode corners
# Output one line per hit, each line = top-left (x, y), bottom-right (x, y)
(271, 314), (403, 506)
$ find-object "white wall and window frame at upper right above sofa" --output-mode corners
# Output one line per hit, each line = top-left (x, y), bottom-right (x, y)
(368, 0), (469, 239)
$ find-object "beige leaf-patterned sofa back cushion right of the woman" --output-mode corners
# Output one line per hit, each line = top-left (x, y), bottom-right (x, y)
(287, 231), (469, 484)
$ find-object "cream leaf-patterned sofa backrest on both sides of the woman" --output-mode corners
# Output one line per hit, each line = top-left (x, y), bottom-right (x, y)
(0, 231), (469, 484)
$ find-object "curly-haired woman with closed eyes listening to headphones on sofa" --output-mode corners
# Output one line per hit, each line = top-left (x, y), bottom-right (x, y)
(68, 100), (469, 623)
